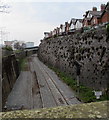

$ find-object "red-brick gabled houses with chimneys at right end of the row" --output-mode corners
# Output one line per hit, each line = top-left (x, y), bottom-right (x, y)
(83, 2), (109, 27)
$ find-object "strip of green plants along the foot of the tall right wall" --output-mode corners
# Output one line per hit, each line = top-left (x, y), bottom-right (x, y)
(48, 66), (109, 103)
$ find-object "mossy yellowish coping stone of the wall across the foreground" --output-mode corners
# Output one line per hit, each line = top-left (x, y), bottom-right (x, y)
(0, 101), (109, 118)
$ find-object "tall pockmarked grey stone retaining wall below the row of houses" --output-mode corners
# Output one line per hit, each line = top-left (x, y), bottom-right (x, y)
(38, 28), (109, 91)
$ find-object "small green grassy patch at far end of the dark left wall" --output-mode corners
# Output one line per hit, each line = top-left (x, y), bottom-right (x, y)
(19, 58), (28, 71)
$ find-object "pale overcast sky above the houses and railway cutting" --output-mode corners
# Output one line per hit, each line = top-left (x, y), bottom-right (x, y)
(0, 0), (108, 45)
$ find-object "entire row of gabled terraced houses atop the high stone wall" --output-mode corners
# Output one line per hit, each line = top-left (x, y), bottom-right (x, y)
(44, 2), (109, 38)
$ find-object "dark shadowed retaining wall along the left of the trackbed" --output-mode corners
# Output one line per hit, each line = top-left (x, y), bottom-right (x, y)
(2, 55), (19, 107)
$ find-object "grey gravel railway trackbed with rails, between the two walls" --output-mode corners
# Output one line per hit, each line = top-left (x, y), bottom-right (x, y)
(5, 54), (80, 110)
